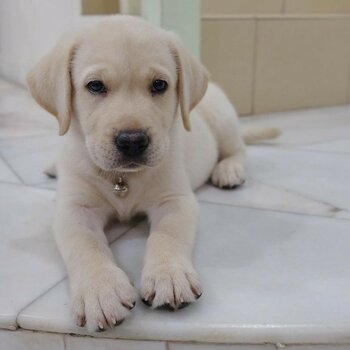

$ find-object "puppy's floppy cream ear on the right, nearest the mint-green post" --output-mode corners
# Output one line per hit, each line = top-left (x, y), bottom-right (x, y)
(172, 35), (209, 131)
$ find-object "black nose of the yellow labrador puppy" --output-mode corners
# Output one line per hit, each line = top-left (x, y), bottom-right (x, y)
(115, 131), (149, 157)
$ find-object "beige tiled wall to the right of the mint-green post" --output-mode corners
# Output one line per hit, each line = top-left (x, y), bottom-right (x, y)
(201, 0), (350, 115)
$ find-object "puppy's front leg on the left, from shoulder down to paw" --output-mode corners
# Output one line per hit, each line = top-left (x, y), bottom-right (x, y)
(54, 183), (135, 331)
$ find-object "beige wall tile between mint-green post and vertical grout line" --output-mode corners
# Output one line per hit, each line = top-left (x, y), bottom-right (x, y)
(201, 19), (255, 114)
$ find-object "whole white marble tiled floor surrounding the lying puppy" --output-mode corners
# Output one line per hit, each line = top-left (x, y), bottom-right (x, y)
(0, 81), (350, 350)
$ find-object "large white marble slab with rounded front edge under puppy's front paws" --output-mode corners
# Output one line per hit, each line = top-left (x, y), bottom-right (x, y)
(19, 204), (350, 344)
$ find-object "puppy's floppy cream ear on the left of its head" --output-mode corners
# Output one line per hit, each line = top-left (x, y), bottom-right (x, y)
(27, 35), (75, 135)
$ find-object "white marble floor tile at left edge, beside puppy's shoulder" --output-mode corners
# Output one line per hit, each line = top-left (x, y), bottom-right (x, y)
(0, 136), (61, 185)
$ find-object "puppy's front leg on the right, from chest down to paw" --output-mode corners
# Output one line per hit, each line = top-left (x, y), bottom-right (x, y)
(141, 193), (202, 310)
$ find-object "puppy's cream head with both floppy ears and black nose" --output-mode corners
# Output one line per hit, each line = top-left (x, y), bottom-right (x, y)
(27, 16), (208, 171)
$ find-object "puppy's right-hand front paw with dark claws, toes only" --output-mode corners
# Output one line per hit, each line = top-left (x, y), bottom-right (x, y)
(141, 261), (202, 311)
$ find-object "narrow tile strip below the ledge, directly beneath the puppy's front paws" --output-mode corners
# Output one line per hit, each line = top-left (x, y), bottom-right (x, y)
(66, 335), (167, 350)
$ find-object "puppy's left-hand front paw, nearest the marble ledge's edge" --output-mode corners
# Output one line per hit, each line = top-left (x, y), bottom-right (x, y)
(71, 265), (135, 332)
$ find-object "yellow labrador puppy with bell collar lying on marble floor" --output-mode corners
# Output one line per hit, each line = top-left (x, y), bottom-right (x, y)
(28, 16), (274, 330)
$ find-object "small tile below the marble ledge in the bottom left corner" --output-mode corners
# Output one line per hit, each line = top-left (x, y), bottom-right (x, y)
(0, 330), (65, 350)
